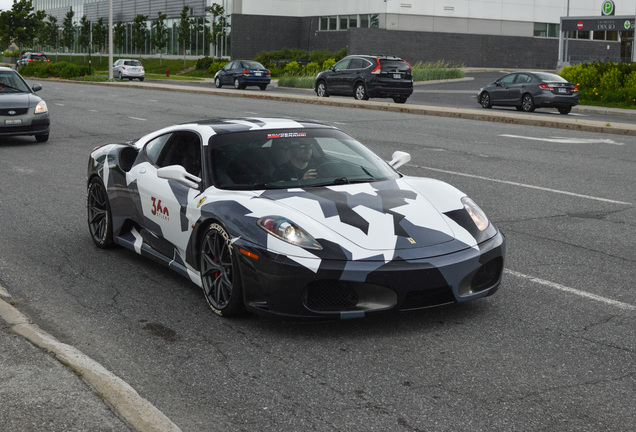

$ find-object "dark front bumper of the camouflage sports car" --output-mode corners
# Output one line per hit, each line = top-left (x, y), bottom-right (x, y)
(235, 232), (505, 319)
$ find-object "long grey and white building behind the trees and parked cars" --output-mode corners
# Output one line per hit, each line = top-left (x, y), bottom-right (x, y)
(34, 0), (636, 69)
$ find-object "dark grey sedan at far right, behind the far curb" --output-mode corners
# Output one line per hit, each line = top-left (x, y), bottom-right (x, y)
(477, 71), (579, 114)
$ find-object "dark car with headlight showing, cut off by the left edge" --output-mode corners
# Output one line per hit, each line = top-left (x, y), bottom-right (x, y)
(0, 67), (50, 142)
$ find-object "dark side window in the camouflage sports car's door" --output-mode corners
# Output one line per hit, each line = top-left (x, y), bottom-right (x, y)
(157, 132), (201, 177)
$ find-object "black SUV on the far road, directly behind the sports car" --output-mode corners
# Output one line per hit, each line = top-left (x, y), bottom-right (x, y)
(314, 55), (413, 103)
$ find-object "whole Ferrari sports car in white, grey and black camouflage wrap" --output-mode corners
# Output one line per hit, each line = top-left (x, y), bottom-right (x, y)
(87, 118), (505, 319)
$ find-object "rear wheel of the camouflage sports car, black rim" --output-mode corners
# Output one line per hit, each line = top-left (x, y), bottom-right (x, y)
(86, 177), (113, 249)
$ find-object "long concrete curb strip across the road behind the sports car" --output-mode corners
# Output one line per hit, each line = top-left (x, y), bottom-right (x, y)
(79, 81), (636, 136)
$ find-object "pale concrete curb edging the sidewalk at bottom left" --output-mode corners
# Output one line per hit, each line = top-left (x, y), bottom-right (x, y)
(0, 296), (181, 432)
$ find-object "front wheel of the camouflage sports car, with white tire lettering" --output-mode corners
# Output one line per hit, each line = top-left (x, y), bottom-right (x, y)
(199, 223), (244, 317)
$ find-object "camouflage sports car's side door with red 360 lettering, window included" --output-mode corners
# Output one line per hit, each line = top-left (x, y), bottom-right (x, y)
(131, 131), (202, 258)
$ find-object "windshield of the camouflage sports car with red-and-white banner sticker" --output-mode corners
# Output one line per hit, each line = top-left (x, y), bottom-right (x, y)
(209, 128), (400, 189)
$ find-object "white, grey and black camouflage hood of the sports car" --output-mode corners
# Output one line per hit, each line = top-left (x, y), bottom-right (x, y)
(260, 179), (455, 251)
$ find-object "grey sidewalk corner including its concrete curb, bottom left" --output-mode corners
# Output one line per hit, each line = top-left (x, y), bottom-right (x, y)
(0, 286), (180, 432)
